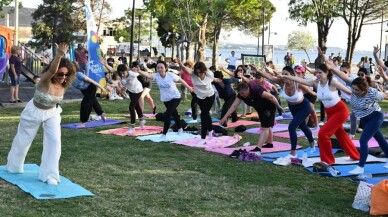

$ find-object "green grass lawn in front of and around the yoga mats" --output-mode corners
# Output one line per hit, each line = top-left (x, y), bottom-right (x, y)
(0, 88), (386, 216)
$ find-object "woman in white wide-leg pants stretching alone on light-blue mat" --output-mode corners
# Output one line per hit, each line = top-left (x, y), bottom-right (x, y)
(7, 44), (76, 185)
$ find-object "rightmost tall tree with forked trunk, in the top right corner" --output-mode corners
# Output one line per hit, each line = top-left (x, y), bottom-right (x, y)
(340, 0), (388, 63)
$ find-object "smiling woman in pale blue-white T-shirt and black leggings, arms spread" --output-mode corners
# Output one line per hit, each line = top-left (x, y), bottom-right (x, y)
(139, 61), (193, 139)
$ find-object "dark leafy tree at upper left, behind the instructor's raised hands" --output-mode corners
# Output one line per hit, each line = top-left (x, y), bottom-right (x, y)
(32, 0), (75, 56)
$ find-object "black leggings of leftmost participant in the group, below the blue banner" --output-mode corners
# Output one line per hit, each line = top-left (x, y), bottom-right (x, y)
(80, 84), (104, 123)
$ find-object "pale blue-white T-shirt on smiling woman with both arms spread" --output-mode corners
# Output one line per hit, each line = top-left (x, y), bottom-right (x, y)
(152, 72), (181, 102)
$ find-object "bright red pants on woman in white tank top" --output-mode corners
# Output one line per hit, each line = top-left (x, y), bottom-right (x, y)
(318, 101), (360, 164)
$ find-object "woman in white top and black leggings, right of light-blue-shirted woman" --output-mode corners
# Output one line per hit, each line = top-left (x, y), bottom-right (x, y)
(183, 62), (215, 146)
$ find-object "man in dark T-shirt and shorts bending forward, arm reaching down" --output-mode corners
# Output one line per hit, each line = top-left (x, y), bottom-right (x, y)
(220, 81), (284, 155)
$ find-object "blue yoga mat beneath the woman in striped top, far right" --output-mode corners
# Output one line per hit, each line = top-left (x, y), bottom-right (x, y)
(306, 163), (388, 177)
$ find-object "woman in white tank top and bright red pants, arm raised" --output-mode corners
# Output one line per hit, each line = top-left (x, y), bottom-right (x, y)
(283, 64), (360, 165)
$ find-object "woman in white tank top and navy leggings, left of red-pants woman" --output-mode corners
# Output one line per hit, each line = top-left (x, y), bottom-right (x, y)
(252, 66), (315, 158)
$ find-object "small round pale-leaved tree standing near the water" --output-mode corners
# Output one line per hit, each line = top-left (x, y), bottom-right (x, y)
(287, 31), (315, 62)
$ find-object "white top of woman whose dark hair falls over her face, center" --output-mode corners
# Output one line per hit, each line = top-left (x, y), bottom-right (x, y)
(191, 71), (214, 99)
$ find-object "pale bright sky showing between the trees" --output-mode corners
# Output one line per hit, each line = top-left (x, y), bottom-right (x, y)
(15, 0), (388, 51)
